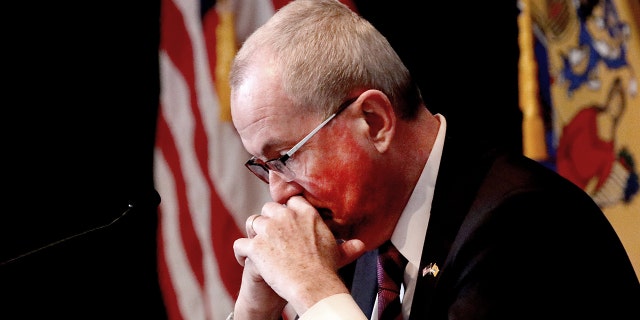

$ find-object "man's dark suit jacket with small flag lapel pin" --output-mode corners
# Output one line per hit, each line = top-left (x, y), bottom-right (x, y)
(342, 124), (640, 320)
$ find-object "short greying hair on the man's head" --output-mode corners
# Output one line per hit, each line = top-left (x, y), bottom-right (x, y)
(230, 0), (422, 118)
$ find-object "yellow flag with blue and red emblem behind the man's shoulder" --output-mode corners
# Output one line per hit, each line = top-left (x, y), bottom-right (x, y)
(518, 0), (640, 278)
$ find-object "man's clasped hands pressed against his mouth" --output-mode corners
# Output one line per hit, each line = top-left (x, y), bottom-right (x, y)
(233, 196), (364, 319)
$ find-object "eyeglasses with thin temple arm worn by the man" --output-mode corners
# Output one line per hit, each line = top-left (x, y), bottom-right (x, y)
(244, 97), (358, 183)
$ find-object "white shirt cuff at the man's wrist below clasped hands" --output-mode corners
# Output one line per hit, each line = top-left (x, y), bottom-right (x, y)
(299, 293), (367, 320)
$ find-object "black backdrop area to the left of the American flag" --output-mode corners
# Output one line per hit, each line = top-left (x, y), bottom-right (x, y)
(0, 1), (166, 319)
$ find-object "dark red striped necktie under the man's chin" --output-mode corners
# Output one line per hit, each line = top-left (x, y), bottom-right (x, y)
(377, 241), (407, 320)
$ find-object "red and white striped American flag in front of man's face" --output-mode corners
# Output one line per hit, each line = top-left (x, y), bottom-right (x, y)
(154, 0), (353, 320)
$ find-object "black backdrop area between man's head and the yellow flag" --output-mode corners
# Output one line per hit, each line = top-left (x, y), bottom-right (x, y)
(354, 0), (522, 152)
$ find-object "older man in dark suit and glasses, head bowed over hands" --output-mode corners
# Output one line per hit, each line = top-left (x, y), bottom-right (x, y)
(230, 0), (640, 319)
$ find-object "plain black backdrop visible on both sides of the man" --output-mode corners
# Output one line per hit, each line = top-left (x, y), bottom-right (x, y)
(0, 0), (521, 319)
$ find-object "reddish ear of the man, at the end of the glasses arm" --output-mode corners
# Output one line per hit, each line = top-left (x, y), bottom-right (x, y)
(360, 90), (396, 152)
